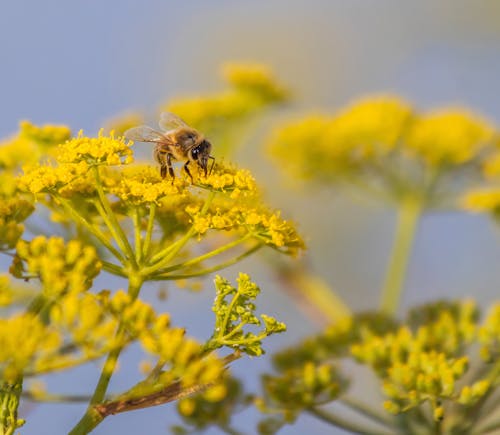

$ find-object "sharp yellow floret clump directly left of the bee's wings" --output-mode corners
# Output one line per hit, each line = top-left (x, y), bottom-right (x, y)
(57, 131), (134, 166)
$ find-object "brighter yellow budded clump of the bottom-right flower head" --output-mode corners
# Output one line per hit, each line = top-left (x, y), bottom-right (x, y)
(351, 302), (494, 420)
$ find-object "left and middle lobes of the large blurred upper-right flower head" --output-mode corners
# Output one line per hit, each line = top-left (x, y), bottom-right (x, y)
(268, 96), (412, 180)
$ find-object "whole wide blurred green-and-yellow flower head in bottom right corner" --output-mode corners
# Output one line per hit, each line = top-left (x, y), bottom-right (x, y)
(260, 301), (500, 433)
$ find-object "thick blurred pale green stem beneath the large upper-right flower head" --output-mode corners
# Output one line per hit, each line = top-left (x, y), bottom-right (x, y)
(380, 194), (423, 315)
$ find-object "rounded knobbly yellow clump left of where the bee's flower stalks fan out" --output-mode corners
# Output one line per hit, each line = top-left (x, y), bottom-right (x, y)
(11, 236), (101, 296)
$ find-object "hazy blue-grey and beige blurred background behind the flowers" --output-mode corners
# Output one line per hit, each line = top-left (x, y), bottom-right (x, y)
(0, 0), (500, 435)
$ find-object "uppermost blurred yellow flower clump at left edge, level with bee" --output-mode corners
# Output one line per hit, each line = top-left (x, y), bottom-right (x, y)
(0, 121), (71, 169)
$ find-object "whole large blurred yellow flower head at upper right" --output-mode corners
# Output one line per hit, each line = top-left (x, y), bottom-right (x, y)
(268, 95), (496, 206)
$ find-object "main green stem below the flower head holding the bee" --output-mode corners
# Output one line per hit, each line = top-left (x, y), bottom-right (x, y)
(69, 274), (143, 435)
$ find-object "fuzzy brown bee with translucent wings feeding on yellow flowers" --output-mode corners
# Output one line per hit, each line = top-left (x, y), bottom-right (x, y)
(125, 112), (215, 182)
